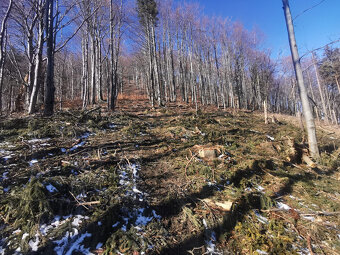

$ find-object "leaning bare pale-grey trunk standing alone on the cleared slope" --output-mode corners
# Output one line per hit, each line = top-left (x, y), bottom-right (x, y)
(282, 0), (320, 159)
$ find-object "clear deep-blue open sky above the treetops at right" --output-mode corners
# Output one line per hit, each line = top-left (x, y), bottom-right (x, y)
(190, 0), (340, 58)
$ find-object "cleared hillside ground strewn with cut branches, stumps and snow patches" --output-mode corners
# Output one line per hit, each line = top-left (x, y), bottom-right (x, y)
(0, 98), (340, 255)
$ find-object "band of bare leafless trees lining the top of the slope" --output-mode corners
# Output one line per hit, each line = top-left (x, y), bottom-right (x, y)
(0, 0), (340, 124)
